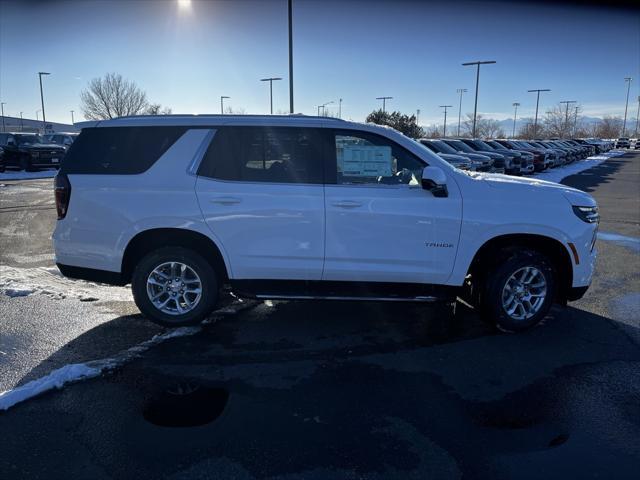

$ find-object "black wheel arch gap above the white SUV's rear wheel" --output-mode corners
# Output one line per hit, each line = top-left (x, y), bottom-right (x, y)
(121, 228), (229, 283)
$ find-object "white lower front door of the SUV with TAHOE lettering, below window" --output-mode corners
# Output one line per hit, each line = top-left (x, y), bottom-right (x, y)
(322, 185), (461, 283)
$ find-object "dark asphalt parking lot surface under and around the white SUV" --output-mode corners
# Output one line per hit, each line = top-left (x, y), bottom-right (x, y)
(0, 152), (640, 479)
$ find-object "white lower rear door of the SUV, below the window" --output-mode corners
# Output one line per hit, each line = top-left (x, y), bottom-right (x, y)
(196, 177), (324, 280)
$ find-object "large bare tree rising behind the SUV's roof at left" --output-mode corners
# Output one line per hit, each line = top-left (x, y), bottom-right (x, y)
(80, 73), (149, 120)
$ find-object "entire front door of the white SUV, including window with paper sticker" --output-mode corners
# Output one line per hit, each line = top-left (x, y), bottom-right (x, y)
(322, 130), (462, 283)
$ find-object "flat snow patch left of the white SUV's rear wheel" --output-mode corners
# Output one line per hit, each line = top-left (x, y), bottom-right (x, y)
(0, 265), (132, 302)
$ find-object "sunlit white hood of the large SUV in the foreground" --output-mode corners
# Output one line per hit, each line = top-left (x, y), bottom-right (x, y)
(469, 173), (596, 207)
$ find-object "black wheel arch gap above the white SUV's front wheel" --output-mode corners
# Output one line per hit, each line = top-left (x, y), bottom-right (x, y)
(467, 234), (573, 302)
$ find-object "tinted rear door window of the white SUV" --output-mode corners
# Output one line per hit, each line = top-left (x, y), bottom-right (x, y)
(198, 127), (323, 183)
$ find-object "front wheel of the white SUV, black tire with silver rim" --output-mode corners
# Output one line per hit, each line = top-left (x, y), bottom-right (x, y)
(480, 249), (557, 332)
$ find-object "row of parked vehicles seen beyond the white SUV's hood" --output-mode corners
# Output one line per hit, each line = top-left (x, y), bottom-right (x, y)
(419, 138), (613, 175)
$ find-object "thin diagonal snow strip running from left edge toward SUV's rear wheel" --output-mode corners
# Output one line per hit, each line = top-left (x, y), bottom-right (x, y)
(0, 299), (255, 411)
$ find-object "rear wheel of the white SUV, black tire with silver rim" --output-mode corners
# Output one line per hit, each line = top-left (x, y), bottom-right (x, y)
(131, 247), (219, 328)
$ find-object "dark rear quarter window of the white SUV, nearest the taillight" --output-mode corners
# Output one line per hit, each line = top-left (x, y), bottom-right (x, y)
(61, 127), (187, 175)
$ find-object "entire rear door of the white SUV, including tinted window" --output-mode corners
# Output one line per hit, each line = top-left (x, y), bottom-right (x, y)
(196, 127), (324, 280)
